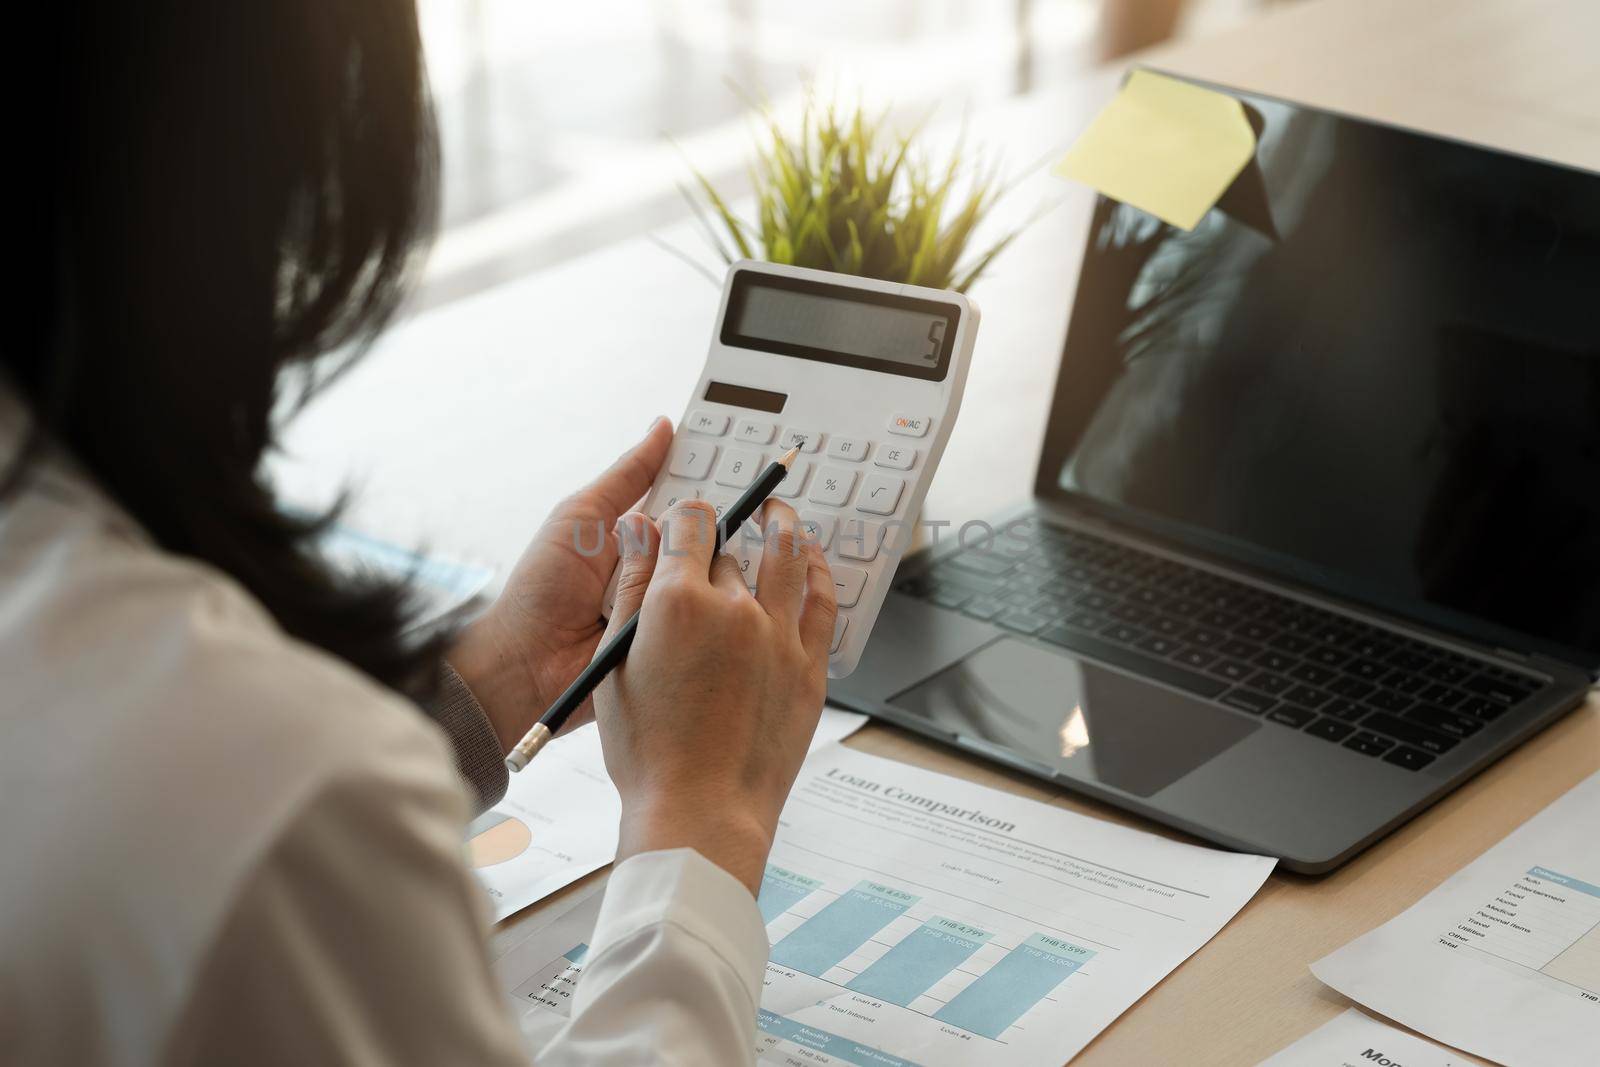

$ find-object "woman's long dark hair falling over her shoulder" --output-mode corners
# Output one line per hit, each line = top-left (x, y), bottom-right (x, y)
(10, 0), (451, 691)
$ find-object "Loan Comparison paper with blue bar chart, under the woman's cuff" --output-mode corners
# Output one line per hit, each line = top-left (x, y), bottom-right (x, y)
(496, 745), (1274, 1067)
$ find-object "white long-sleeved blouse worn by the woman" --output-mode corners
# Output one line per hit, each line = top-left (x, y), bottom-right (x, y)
(0, 389), (768, 1065)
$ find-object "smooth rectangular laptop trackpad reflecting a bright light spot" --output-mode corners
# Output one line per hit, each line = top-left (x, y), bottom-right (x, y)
(888, 638), (1259, 797)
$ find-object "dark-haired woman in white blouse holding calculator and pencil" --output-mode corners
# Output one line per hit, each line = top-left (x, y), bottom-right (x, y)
(0, 0), (834, 1064)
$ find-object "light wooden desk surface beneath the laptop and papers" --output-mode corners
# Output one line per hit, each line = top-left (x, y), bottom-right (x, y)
(280, 0), (1600, 1067)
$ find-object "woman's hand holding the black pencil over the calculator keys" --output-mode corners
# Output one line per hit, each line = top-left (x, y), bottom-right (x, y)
(595, 501), (837, 893)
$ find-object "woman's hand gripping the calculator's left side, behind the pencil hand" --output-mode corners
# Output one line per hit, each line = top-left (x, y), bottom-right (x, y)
(448, 419), (672, 752)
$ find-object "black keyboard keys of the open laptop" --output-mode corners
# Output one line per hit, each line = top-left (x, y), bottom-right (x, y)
(896, 522), (1544, 771)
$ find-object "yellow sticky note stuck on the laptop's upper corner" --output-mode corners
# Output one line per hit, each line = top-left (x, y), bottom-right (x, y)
(1054, 70), (1256, 230)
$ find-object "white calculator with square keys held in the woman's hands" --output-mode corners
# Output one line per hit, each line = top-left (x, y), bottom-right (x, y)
(608, 261), (978, 678)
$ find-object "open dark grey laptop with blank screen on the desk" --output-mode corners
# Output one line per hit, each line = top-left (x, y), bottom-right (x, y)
(829, 75), (1600, 873)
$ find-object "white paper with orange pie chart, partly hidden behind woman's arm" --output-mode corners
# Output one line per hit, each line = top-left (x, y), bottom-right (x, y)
(467, 707), (867, 921)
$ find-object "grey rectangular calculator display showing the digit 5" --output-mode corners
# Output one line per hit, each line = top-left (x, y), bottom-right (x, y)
(722, 270), (960, 381)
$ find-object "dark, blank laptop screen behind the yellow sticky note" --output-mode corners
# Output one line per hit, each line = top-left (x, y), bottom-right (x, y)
(1037, 77), (1600, 665)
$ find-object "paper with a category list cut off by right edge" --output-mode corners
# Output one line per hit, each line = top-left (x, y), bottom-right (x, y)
(1312, 774), (1600, 1067)
